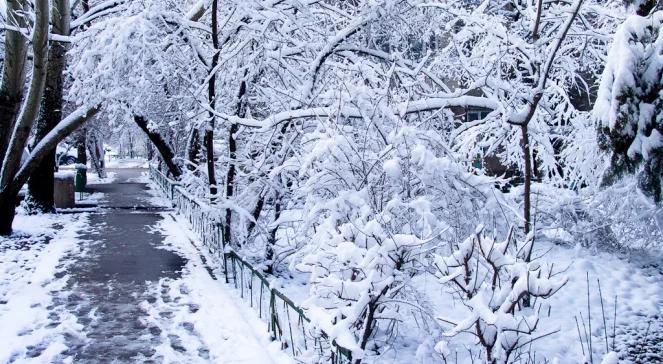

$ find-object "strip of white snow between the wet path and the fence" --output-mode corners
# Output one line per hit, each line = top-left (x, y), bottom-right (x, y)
(153, 213), (293, 363)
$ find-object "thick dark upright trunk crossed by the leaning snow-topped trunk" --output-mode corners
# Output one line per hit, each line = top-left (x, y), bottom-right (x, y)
(27, 0), (71, 212)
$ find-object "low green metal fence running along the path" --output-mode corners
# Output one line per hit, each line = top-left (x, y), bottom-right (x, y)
(150, 165), (352, 364)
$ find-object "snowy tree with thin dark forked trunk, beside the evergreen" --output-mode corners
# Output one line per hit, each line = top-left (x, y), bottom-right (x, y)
(422, 1), (614, 253)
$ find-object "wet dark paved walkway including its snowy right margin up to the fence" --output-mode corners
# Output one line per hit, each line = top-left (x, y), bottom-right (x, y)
(52, 169), (288, 363)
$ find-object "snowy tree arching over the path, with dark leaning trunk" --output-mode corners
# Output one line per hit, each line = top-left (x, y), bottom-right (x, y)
(68, 2), (207, 176)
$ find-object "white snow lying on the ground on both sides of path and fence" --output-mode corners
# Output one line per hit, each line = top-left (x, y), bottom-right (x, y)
(0, 164), (663, 363)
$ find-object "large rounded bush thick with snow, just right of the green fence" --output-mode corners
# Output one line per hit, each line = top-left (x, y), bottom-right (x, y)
(288, 90), (504, 358)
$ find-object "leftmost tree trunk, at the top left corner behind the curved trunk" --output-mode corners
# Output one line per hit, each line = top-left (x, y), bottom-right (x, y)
(0, 0), (28, 164)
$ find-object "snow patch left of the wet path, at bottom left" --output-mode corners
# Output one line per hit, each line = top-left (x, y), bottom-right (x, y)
(0, 214), (88, 363)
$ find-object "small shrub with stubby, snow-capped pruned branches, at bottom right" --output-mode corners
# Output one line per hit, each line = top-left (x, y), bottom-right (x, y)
(435, 226), (566, 363)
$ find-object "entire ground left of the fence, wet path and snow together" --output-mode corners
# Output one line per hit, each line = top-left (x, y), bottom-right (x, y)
(0, 167), (293, 363)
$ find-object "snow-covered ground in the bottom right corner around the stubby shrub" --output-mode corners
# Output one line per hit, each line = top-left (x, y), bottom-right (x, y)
(404, 242), (663, 363)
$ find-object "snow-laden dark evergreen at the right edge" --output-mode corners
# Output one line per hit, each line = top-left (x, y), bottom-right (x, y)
(594, 4), (663, 203)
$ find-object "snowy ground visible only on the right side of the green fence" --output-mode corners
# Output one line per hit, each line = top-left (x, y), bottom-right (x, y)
(148, 173), (663, 364)
